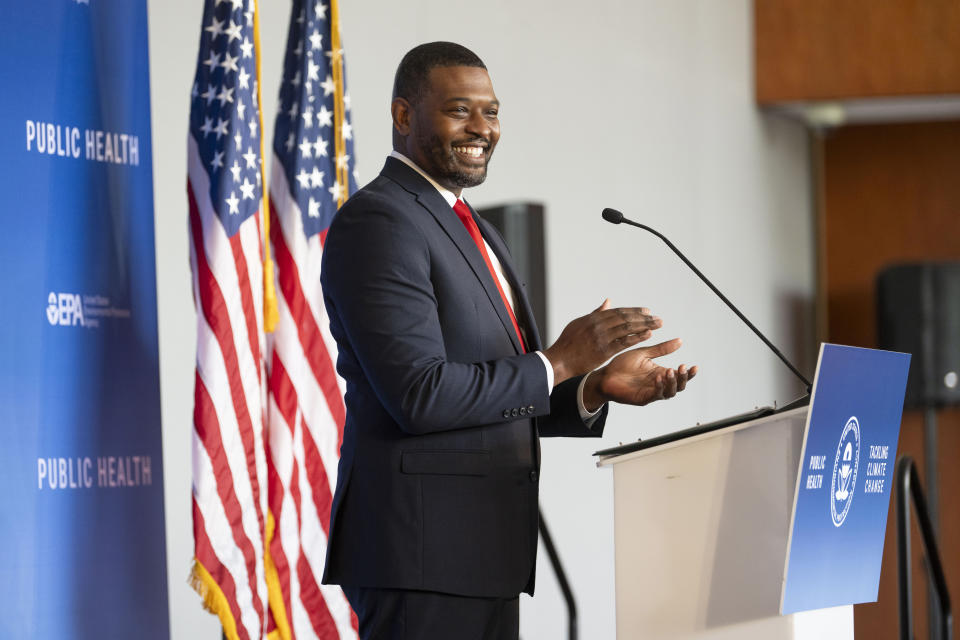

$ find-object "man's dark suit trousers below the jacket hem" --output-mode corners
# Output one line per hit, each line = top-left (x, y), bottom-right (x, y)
(343, 586), (520, 640)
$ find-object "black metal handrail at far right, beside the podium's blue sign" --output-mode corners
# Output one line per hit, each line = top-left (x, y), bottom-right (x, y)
(896, 456), (953, 640)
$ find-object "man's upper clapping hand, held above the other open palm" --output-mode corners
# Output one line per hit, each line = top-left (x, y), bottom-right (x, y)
(543, 299), (663, 385)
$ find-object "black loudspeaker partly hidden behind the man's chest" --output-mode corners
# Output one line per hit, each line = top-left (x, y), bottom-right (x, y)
(477, 202), (548, 340)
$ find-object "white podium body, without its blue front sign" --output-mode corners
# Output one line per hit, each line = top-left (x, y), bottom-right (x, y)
(598, 407), (853, 640)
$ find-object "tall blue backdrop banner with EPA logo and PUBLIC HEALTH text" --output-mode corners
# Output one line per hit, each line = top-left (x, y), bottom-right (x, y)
(0, 0), (169, 639)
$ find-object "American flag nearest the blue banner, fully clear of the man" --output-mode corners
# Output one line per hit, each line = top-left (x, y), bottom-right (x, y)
(187, 0), (272, 640)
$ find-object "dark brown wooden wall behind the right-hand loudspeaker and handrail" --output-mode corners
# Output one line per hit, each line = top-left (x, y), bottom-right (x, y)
(819, 121), (960, 640)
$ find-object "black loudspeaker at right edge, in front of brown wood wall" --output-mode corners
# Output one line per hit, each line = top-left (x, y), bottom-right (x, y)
(877, 262), (960, 408)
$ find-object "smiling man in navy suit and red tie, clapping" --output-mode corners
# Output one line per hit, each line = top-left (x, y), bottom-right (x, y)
(321, 42), (696, 640)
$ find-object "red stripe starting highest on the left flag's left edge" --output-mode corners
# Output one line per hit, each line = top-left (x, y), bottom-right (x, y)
(187, 180), (264, 544)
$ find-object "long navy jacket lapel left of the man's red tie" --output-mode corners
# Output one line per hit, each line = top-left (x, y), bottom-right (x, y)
(381, 158), (523, 353)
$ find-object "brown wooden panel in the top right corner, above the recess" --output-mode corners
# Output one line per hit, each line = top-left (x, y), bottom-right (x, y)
(754, 0), (960, 104)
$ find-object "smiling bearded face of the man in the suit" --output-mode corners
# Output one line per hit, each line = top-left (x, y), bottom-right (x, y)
(395, 67), (500, 195)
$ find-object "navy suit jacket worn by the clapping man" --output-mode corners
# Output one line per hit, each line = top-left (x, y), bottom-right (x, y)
(321, 158), (606, 597)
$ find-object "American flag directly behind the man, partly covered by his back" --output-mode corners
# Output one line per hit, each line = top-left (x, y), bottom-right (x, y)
(268, 0), (357, 639)
